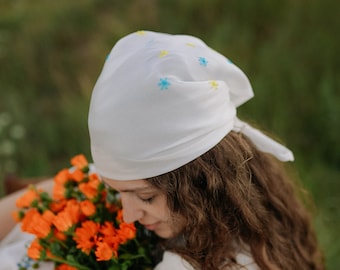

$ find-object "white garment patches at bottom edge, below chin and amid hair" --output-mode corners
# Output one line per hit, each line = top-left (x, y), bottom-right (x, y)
(155, 251), (259, 270)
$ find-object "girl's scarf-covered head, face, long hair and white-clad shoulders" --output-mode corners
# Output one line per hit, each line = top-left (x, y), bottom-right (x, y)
(89, 31), (323, 270)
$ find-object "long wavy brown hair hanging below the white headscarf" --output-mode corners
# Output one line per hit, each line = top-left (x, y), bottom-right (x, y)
(147, 131), (324, 270)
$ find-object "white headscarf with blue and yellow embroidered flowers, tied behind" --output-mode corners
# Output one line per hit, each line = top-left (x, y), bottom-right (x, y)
(89, 31), (293, 180)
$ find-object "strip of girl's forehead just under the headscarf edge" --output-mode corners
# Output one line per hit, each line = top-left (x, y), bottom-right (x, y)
(101, 177), (152, 192)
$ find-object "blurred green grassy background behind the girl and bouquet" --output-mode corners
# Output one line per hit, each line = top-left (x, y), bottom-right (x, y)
(0, 0), (340, 270)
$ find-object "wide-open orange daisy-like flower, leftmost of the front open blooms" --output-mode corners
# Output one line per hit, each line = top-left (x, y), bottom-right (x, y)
(73, 220), (100, 254)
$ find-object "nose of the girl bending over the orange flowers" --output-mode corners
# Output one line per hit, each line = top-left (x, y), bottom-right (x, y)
(120, 193), (144, 223)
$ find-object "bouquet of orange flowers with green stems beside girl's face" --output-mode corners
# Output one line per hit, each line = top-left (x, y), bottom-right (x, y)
(15, 155), (154, 270)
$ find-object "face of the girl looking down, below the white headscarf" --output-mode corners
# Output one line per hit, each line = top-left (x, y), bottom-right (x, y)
(103, 177), (185, 239)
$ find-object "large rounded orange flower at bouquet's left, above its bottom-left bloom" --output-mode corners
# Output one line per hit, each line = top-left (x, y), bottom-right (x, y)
(21, 208), (51, 238)
